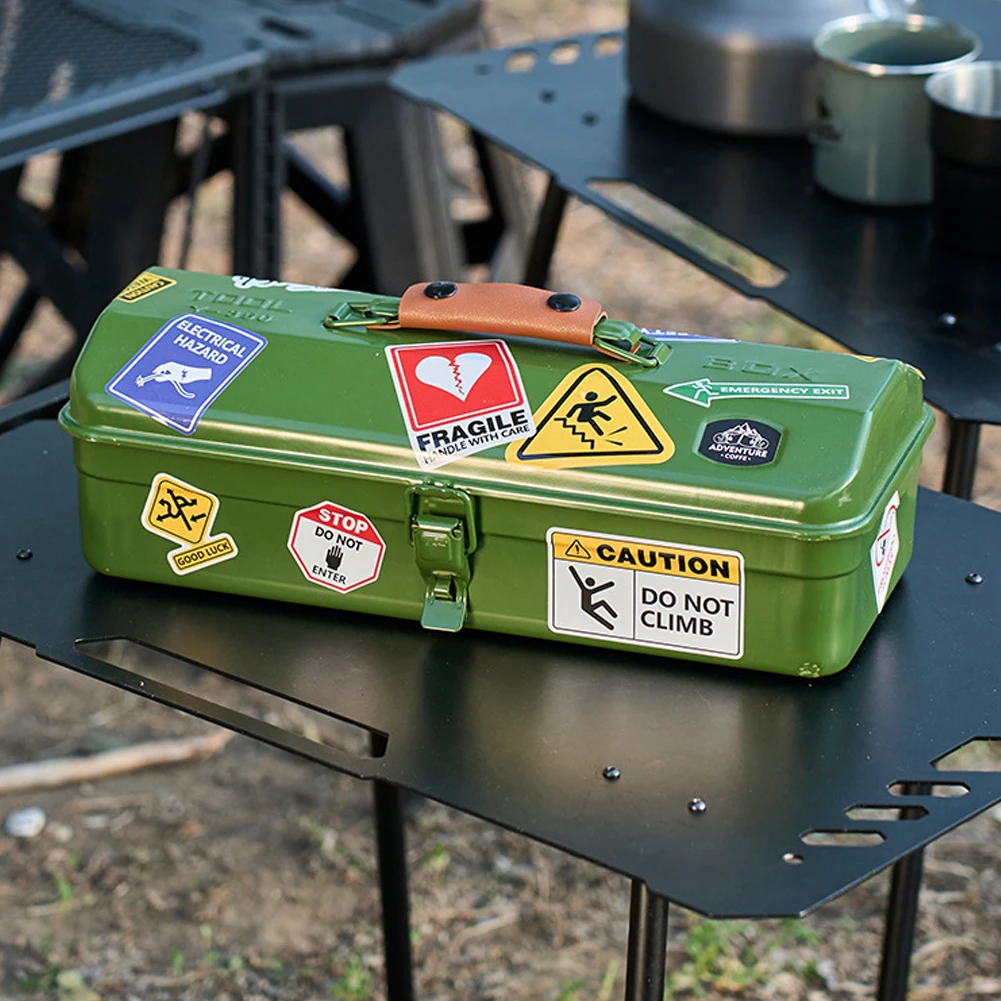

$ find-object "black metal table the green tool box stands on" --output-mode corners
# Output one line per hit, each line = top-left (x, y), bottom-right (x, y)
(0, 386), (1001, 1001)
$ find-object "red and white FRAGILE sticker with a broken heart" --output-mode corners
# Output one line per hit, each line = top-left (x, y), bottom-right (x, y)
(385, 340), (536, 469)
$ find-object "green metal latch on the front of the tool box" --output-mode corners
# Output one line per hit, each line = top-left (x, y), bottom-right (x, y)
(406, 481), (476, 633)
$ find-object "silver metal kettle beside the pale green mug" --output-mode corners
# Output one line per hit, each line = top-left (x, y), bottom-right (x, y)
(627, 0), (919, 135)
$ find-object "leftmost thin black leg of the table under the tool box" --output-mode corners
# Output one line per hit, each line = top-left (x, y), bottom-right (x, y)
(372, 780), (413, 1001)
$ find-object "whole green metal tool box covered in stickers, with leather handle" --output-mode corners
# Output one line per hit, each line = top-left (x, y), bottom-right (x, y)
(60, 268), (932, 678)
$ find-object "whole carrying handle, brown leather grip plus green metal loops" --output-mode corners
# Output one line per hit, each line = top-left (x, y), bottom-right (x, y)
(323, 281), (668, 367)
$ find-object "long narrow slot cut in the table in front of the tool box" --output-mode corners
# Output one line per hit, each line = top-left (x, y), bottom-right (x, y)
(74, 638), (389, 759)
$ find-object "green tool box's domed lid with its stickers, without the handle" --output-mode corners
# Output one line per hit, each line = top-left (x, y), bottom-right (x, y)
(62, 267), (931, 540)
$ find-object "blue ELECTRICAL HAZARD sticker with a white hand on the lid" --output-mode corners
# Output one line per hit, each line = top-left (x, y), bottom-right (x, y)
(105, 313), (267, 434)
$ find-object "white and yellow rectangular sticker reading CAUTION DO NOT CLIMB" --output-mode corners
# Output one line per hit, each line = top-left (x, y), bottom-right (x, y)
(547, 529), (744, 660)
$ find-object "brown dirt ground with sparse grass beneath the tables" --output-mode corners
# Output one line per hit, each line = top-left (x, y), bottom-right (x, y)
(0, 0), (1001, 1001)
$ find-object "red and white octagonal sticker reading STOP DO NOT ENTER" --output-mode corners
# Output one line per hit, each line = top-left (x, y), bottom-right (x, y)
(288, 501), (385, 595)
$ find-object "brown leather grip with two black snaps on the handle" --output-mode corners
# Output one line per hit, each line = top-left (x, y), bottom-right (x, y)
(394, 281), (606, 345)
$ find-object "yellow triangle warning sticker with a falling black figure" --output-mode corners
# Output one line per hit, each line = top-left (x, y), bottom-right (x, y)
(506, 362), (675, 469)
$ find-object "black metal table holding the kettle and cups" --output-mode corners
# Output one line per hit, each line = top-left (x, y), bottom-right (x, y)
(394, 0), (1001, 497)
